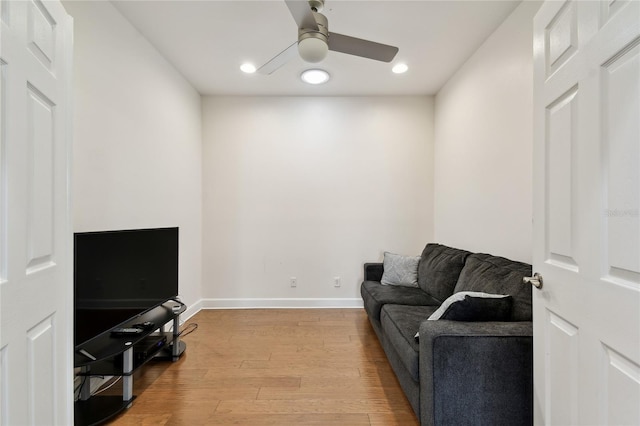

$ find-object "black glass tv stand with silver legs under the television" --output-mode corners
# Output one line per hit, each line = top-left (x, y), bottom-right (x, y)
(74, 301), (187, 426)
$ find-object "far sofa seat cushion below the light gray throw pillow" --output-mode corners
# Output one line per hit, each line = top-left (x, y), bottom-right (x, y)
(360, 281), (440, 321)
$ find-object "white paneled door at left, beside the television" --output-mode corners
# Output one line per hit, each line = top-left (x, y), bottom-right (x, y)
(0, 0), (73, 426)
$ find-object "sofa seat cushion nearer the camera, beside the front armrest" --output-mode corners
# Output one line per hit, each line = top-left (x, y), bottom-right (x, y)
(380, 305), (438, 382)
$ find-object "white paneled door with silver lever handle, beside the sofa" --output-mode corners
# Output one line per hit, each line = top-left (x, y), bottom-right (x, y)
(533, 0), (640, 425)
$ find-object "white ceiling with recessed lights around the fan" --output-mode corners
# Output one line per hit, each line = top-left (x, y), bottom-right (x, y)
(112, 0), (521, 96)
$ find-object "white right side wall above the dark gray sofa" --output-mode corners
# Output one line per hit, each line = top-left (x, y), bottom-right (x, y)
(434, 1), (540, 262)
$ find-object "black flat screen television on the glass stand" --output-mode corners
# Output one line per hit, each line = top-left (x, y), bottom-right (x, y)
(73, 228), (178, 347)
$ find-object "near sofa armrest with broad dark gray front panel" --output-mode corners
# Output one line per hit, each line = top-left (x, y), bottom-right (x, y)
(419, 320), (533, 425)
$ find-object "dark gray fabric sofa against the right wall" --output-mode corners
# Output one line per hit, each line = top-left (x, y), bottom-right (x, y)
(360, 244), (533, 426)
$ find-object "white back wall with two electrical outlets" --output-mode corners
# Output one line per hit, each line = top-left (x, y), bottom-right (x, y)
(203, 97), (433, 306)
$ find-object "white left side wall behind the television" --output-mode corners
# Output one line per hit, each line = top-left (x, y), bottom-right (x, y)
(64, 1), (202, 312)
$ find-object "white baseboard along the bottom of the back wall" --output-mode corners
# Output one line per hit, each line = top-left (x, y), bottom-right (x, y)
(197, 298), (363, 310)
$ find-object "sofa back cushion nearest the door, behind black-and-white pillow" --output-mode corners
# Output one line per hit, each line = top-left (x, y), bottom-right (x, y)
(454, 253), (532, 321)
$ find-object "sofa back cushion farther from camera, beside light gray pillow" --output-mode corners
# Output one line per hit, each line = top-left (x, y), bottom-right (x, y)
(418, 243), (471, 303)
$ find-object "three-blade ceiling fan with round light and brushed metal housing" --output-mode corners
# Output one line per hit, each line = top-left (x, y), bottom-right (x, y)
(258, 0), (398, 74)
